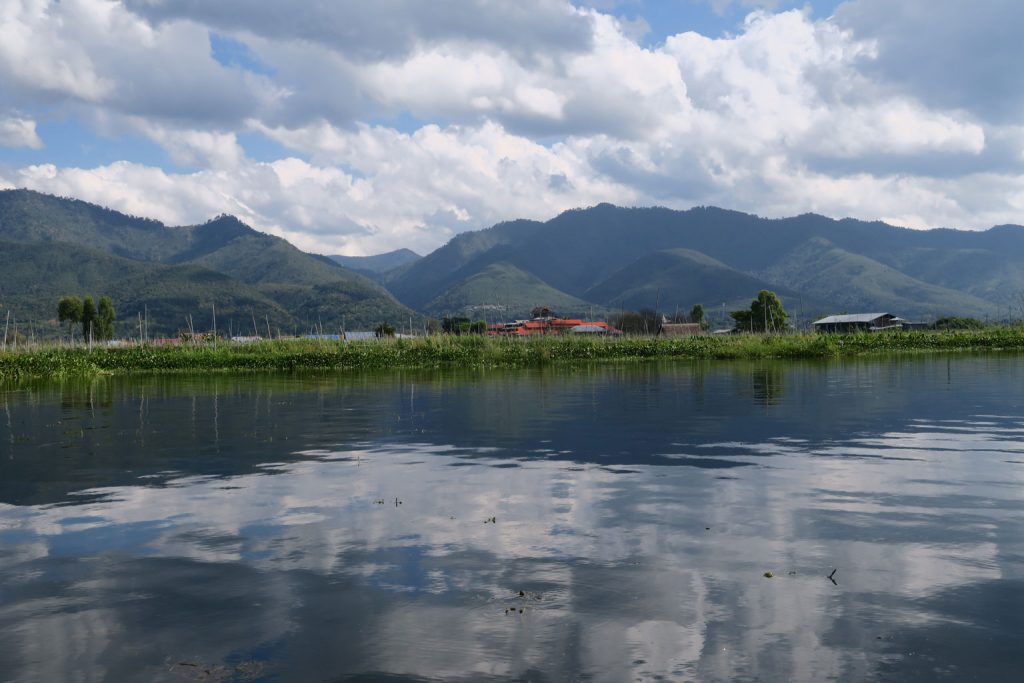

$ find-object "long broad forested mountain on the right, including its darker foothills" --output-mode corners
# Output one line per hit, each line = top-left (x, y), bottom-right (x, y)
(385, 204), (1024, 321)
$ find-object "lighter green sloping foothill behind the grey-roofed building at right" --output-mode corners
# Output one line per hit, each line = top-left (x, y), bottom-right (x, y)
(761, 238), (997, 316)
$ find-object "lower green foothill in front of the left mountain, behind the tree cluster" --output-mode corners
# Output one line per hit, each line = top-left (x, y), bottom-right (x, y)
(0, 242), (292, 336)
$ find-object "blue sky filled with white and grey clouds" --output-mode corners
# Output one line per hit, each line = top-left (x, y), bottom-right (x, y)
(0, 0), (1024, 256)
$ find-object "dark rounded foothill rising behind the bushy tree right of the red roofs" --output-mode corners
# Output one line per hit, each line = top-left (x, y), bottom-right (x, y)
(585, 249), (815, 312)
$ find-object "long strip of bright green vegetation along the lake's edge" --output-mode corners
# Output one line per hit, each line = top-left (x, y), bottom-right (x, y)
(0, 328), (1024, 381)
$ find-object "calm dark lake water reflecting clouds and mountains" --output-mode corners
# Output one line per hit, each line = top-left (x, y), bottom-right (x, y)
(0, 355), (1024, 681)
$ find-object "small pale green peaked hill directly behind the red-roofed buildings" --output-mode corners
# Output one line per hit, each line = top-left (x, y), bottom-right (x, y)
(425, 262), (604, 322)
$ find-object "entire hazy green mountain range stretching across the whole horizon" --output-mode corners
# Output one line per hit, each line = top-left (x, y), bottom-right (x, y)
(0, 190), (1024, 334)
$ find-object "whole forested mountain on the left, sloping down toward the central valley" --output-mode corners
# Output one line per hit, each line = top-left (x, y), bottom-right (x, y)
(0, 190), (419, 334)
